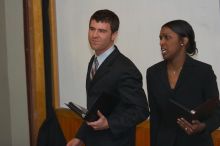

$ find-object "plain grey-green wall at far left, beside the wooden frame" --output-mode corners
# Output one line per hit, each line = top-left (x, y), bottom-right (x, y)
(0, 0), (30, 146)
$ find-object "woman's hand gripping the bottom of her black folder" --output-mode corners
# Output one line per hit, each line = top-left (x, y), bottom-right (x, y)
(177, 118), (206, 135)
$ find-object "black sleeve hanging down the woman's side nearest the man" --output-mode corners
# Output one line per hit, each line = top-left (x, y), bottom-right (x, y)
(146, 70), (160, 146)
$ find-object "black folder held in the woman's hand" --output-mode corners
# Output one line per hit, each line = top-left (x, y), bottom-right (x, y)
(169, 97), (219, 122)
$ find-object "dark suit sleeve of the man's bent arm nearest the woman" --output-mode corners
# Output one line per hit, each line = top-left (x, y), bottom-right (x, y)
(108, 67), (149, 136)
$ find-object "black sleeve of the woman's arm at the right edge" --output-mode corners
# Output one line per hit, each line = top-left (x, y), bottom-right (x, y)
(203, 66), (220, 132)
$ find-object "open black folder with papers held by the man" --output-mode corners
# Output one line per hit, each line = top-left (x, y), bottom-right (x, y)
(65, 92), (117, 122)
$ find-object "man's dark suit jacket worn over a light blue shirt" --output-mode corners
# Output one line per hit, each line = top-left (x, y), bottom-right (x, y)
(76, 46), (149, 146)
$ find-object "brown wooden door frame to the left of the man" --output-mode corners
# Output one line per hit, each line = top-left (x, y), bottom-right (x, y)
(23, 0), (59, 146)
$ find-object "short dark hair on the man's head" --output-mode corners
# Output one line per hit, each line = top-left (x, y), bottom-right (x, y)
(89, 9), (120, 33)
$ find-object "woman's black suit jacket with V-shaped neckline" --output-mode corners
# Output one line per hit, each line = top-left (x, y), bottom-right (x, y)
(147, 56), (220, 146)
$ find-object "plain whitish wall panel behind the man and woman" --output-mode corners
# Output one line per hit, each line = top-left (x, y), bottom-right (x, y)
(56, 0), (220, 105)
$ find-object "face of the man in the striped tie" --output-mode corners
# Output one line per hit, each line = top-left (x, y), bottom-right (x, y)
(88, 20), (117, 55)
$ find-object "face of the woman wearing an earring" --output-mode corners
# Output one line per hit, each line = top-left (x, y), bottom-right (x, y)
(159, 27), (185, 60)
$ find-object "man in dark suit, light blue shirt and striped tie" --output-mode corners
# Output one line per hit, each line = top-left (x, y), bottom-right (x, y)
(67, 10), (149, 146)
